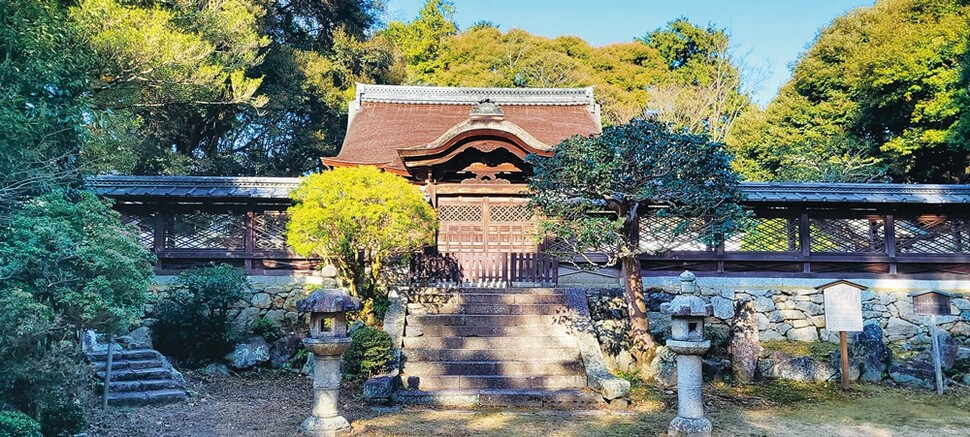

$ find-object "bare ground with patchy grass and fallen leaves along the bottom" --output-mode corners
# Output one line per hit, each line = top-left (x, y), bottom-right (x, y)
(81, 372), (970, 437)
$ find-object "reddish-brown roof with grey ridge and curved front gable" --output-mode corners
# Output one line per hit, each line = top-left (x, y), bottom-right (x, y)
(323, 85), (601, 181)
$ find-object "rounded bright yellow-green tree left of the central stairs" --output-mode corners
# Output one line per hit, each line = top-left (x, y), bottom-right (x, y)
(287, 167), (437, 299)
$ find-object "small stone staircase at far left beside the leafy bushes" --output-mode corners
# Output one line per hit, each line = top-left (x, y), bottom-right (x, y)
(88, 349), (186, 406)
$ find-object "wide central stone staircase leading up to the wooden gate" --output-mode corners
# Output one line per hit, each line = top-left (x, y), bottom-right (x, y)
(395, 288), (603, 408)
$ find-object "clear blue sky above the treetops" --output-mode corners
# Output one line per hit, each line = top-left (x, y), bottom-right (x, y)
(387, 0), (875, 105)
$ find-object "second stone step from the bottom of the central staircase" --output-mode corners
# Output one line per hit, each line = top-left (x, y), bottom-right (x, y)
(405, 375), (586, 390)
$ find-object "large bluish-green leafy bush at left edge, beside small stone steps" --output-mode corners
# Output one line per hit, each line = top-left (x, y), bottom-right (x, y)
(0, 191), (154, 435)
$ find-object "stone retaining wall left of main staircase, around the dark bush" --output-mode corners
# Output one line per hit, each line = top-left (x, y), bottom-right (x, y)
(145, 267), (337, 334)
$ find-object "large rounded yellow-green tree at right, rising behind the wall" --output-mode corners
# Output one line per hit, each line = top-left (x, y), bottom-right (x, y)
(727, 0), (970, 183)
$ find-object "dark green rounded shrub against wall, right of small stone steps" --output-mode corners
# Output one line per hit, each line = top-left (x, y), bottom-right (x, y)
(152, 264), (251, 366)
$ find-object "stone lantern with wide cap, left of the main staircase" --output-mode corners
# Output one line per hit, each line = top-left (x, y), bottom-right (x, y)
(296, 288), (361, 437)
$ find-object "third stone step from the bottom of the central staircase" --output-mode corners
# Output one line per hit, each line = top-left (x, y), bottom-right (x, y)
(404, 360), (586, 376)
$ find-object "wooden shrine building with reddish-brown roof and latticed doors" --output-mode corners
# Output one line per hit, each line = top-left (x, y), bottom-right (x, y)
(323, 84), (602, 254)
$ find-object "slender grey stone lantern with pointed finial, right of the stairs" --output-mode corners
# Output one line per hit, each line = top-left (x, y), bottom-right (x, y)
(660, 271), (714, 437)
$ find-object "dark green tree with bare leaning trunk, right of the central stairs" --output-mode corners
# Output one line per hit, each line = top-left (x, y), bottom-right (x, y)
(528, 119), (744, 356)
